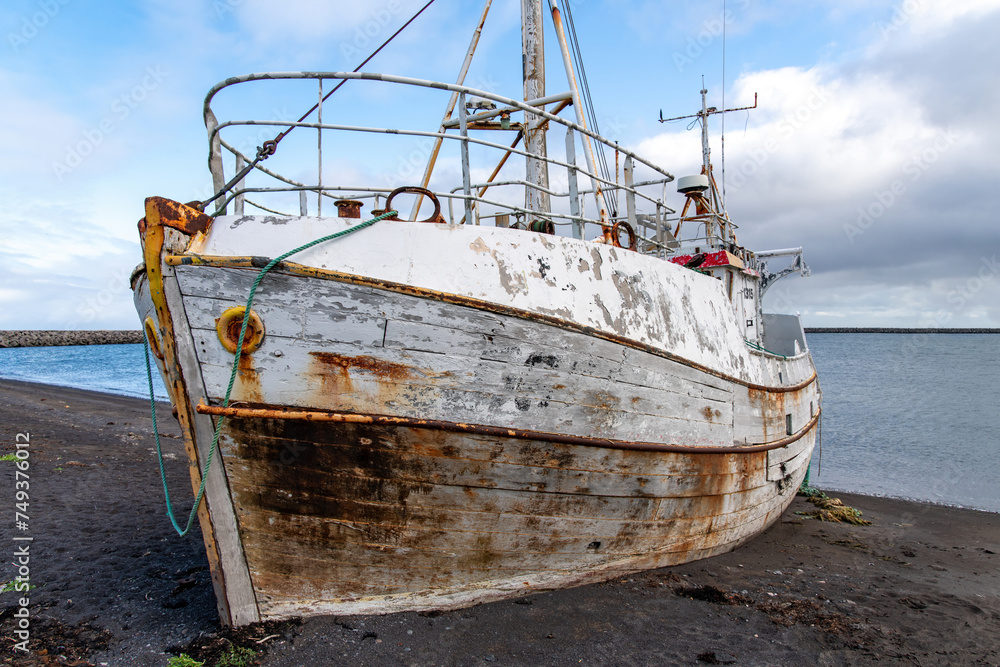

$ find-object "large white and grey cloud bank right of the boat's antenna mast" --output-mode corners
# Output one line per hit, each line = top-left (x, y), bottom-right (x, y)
(640, 0), (1000, 326)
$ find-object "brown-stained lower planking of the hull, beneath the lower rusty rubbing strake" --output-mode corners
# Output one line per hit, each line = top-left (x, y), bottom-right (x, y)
(223, 419), (812, 618)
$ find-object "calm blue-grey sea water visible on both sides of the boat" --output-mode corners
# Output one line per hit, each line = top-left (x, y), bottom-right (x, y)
(0, 334), (1000, 512)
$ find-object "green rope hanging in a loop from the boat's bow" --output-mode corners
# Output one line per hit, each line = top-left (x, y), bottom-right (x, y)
(143, 211), (397, 537)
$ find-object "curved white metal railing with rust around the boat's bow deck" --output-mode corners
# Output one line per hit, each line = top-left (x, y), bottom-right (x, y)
(203, 72), (676, 256)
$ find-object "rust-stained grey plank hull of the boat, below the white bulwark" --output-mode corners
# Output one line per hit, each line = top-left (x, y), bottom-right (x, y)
(134, 204), (819, 625)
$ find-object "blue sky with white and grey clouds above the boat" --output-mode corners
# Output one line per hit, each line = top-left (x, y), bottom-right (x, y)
(0, 0), (1000, 329)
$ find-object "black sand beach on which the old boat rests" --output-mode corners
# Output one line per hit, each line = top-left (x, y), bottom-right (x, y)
(0, 380), (1000, 667)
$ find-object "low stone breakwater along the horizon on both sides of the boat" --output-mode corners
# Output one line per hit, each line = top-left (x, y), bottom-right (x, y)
(0, 327), (1000, 348)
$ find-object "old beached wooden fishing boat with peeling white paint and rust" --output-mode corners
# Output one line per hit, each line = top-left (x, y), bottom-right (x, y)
(132, 0), (821, 626)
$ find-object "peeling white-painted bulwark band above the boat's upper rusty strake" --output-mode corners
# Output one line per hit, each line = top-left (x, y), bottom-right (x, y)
(199, 216), (770, 383)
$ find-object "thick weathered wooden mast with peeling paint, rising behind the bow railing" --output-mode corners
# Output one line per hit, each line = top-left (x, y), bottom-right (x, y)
(521, 0), (552, 222)
